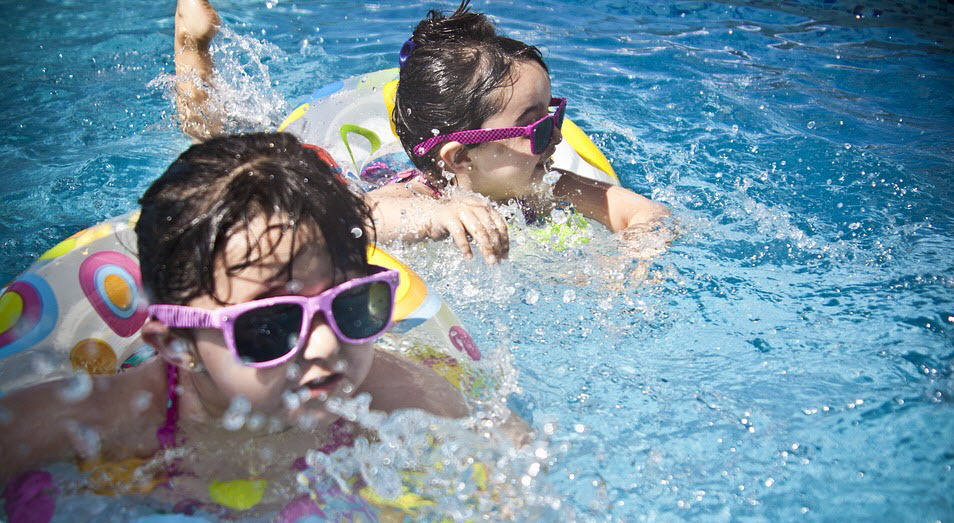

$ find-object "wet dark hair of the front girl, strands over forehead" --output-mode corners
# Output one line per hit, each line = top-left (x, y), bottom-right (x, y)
(136, 133), (371, 304)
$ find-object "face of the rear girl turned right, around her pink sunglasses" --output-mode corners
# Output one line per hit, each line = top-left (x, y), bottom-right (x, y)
(455, 62), (562, 201)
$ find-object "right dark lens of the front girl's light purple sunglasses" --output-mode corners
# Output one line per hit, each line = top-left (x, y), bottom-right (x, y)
(331, 282), (394, 339)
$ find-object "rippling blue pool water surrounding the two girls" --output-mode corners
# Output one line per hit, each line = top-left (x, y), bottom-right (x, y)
(0, 0), (954, 522)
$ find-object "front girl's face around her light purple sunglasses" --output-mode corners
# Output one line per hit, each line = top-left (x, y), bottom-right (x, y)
(188, 217), (373, 426)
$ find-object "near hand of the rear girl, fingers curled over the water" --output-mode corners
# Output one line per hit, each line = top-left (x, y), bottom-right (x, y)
(427, 195), (510, 263)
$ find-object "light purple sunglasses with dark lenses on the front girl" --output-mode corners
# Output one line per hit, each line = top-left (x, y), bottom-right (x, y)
(149, 265), (398, 368)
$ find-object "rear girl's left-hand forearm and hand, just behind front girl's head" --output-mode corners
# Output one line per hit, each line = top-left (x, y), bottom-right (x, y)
(365, 181), (510, 263)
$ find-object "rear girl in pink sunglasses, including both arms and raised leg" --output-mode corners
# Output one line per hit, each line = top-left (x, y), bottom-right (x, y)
(175, 0), (669, 263)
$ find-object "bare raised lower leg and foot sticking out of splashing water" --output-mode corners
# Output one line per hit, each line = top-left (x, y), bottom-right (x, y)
(174, 0), (222, 142)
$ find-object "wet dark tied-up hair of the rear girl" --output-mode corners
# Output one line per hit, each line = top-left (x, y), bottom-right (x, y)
(391, 0), (549, 183)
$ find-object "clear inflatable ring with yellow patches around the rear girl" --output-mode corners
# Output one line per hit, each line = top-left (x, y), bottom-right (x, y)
(278, 69), (619, 185)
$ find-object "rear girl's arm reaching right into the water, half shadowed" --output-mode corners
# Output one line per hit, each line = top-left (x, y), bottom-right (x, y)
(553, 170), (670, 232)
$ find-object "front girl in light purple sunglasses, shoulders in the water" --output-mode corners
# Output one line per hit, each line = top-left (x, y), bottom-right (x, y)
(0, 133), (468, 517)
